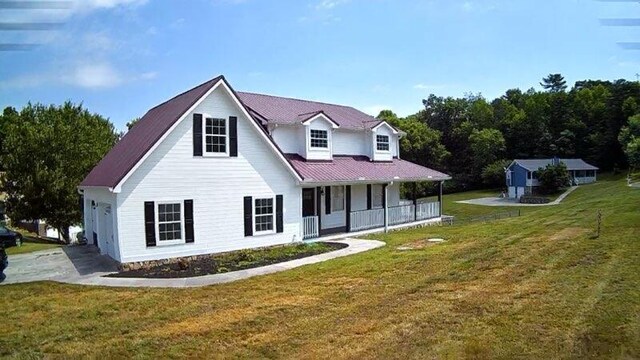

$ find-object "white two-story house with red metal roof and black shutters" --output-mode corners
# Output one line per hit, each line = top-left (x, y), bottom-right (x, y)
(79, 76), (449, 263)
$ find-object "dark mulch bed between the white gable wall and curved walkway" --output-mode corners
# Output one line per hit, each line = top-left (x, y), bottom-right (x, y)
(106, 242), (348, 279)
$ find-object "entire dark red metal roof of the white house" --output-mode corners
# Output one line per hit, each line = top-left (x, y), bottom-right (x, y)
(80, 76), (449, 188)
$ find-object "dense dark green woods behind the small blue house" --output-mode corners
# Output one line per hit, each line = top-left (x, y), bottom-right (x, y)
(378, 74), (640, 191)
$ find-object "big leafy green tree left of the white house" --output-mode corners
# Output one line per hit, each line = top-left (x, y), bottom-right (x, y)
(0, 102), (118, 240)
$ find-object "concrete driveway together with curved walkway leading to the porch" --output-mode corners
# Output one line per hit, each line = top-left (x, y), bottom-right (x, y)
(0, 238), (385, 288)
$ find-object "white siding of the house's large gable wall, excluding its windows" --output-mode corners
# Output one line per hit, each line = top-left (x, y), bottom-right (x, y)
(117, 87), (302, 262)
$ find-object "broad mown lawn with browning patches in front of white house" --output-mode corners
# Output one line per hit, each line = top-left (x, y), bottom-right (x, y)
(0, 176), (640, 359)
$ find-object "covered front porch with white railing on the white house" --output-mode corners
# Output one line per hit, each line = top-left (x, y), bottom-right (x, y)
(301, 181), (443, 240)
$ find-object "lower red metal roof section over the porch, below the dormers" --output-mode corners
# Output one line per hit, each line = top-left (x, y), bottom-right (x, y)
(286, 154), (451, 183)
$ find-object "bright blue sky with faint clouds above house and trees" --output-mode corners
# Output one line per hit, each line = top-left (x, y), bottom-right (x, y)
(0, 0), (640, 128)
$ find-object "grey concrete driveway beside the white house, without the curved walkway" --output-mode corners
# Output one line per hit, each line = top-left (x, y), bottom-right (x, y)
(0, 245), (118, 285)
